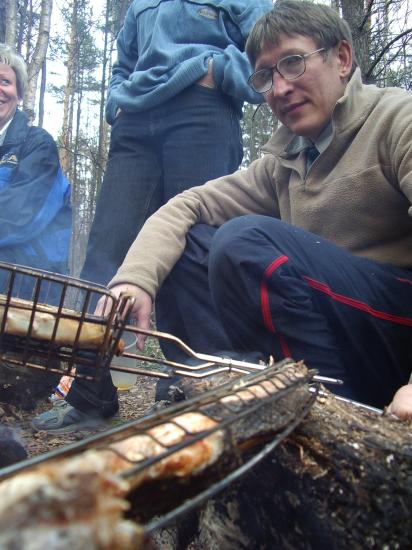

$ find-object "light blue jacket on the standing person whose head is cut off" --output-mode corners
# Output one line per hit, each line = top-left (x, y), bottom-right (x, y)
(106, 0), (273, 124)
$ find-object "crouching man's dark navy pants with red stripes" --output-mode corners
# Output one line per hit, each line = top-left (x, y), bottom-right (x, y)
(157, 216), (412, 407)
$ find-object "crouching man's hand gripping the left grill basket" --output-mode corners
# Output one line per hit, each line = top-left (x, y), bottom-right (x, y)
(95, 283), (153, 350)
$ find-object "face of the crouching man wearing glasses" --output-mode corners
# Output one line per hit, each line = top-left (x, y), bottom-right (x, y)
(255, 34), (352, 140)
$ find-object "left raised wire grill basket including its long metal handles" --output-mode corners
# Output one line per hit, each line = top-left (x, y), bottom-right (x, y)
(0, 262), (342, 394)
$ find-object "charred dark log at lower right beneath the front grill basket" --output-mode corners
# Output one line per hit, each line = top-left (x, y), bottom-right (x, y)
(181, 396), (412, 550)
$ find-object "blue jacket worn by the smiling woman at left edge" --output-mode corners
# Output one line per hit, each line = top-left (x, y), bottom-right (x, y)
(0, 111), (71, 273)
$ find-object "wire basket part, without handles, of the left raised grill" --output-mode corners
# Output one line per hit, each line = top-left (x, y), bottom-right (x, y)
(0, 262), (128, 378)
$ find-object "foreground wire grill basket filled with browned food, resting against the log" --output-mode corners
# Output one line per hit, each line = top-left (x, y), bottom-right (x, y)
(0, 361), (318, 540)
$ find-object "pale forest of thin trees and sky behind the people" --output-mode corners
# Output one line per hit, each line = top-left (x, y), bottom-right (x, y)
(0, 0), (412, 276)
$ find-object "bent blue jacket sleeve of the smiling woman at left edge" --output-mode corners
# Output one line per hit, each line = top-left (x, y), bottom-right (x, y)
(0, 128), (68, 247)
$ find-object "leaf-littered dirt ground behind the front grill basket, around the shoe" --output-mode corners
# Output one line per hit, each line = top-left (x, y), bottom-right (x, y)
(0, 376), (156, 457)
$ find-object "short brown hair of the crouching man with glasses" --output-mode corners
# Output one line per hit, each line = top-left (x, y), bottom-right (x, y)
(246, 0), (353, 67)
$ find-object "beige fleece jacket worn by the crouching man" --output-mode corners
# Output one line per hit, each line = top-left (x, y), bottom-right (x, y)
(109, 70), (412, 298)
